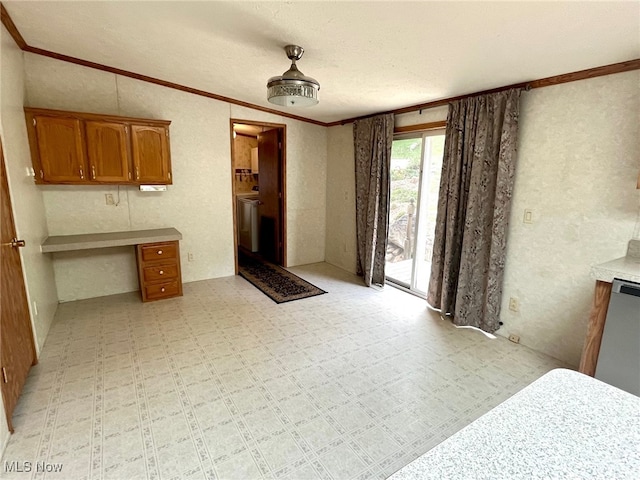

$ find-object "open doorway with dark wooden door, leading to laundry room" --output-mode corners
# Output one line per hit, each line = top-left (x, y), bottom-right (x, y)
(231, 119), (287, 274)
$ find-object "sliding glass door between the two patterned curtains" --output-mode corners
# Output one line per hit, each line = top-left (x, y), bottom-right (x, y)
(385, 130), (444, 295)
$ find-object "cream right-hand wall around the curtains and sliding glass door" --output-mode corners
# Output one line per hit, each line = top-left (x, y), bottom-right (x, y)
(326, 71), (640, 366)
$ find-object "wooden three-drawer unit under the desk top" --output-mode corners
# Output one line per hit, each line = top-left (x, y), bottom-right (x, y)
(136, 241), (182, 302)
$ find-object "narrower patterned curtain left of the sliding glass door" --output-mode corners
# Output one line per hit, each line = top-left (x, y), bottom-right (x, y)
(353, 114), (393, 286)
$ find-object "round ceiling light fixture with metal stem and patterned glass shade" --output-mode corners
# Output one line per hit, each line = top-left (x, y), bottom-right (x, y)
(267, 45), (320, 107)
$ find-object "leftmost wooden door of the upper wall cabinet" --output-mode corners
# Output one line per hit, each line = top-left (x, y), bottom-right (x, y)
(34, 116), (87, 183)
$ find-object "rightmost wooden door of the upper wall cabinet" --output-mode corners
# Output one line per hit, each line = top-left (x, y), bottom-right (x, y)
(131, 125), (171, 184)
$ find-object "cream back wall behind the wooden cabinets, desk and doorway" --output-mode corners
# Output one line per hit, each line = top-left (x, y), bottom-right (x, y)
(25, 54), (326, 301)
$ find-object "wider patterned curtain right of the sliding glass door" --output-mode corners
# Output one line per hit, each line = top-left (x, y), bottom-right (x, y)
(427, 89), (521, 333)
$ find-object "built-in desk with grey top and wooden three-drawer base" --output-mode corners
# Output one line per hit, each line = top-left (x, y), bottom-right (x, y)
(41, 228), (182, 302)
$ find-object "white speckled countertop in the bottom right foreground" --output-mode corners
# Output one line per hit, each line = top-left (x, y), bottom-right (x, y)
(390, 369), (640, 480)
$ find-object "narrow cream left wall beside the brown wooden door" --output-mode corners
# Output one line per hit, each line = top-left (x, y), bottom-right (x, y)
(0, 27), (58, 456)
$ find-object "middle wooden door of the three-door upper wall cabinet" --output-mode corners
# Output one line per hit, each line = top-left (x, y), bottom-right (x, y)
(85, 121), (131, 183)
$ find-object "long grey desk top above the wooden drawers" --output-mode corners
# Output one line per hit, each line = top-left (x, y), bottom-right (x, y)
(41, 228), (182, 253)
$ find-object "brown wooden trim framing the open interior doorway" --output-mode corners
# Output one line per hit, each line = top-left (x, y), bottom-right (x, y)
(229, 118), (288, 275)
